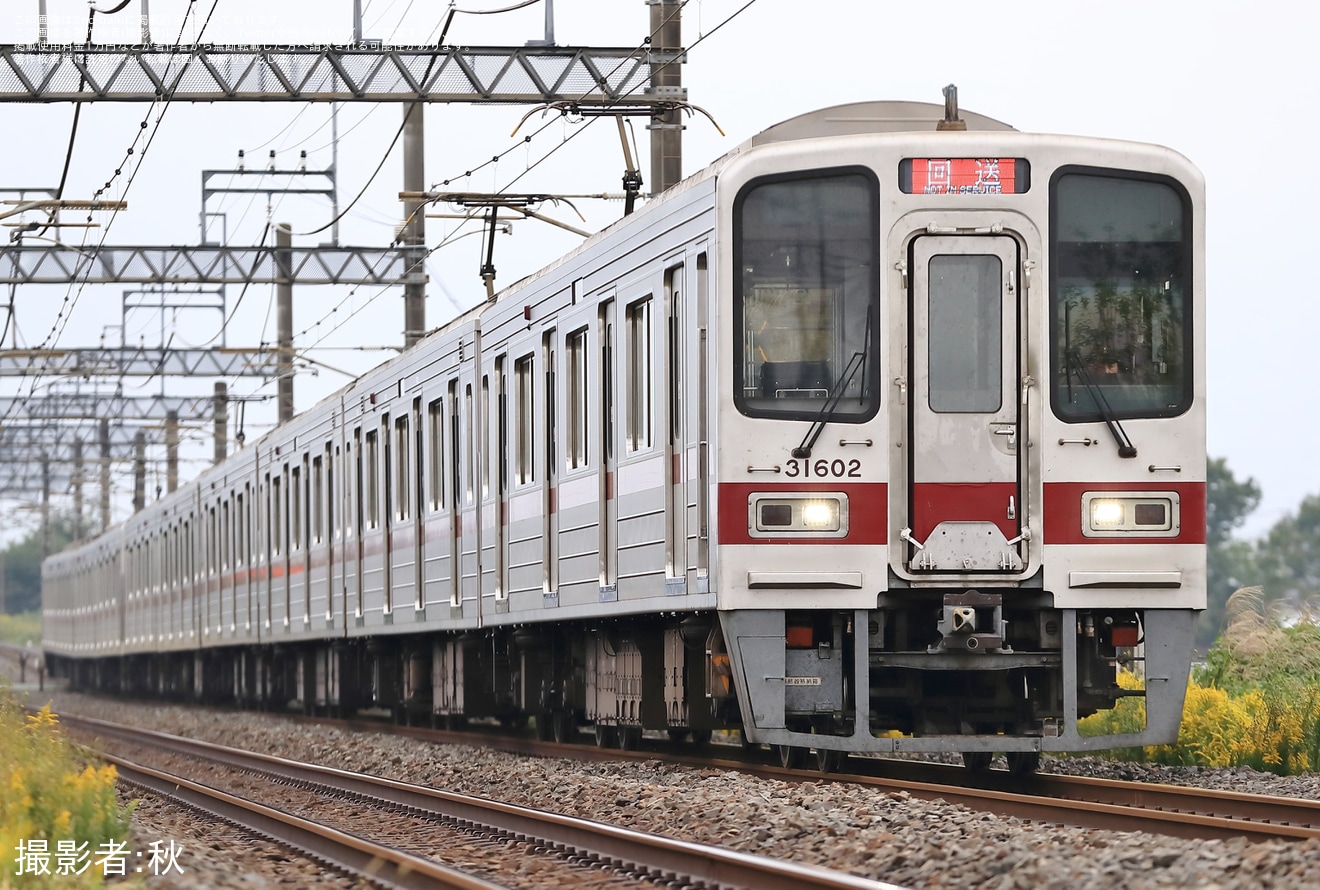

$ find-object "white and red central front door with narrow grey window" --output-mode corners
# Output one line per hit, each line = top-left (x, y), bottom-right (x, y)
(903, 235), (1023, 572)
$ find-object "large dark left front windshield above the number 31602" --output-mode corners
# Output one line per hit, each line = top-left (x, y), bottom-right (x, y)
(733, 169), (879, 423)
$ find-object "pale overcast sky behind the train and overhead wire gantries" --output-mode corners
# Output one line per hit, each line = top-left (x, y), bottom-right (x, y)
(0, 0), (1320, 537)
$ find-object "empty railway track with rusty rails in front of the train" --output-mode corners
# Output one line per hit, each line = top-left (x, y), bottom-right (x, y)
(61, 714), (890, 890)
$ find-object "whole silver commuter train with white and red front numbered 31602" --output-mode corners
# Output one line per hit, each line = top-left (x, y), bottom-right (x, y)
(44, 95), (1205, 771)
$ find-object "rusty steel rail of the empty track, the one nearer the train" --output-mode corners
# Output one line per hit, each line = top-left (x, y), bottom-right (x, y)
(61, 714), (898, 890)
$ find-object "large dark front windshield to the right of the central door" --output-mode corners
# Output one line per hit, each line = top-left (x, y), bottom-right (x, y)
(1049, 170), (1192, 423)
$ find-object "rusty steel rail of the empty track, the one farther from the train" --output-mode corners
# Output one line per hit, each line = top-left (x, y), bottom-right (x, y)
(100, 754), (502, 890)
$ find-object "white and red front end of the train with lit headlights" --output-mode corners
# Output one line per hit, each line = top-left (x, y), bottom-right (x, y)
(715, 133), (1205, 769)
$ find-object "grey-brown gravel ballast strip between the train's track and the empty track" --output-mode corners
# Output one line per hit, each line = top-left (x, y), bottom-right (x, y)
(23, 693), (1320, 890)
